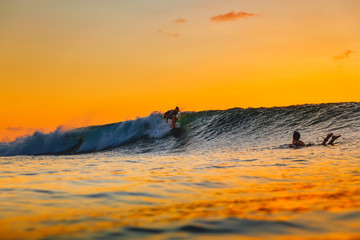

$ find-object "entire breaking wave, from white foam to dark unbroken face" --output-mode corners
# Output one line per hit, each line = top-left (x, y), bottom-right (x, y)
(0, 103), (360, 156)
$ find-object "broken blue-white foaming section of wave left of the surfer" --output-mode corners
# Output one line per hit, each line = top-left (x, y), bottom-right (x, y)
(0, 113), (170, 156)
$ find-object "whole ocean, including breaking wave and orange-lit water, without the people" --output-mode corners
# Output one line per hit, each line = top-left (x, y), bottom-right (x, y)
(0, 102), (360, 239)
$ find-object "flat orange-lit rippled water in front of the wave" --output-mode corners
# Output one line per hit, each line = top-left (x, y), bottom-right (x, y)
(0, 141), (360, 239)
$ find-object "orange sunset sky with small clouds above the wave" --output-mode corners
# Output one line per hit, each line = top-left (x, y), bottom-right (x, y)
(0, 0), (360, 140)
